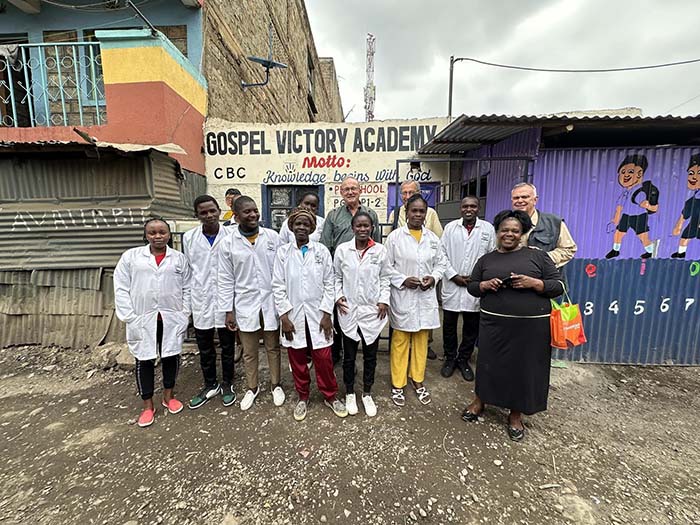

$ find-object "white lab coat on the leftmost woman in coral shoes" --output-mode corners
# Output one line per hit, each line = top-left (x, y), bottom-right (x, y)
(114, 246), (190, 361)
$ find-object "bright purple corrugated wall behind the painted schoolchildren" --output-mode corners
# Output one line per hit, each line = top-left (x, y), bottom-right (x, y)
(532, 147), (700, 259)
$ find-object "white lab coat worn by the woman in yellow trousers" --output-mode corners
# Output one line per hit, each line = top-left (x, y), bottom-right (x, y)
(385, 226), (447, 332)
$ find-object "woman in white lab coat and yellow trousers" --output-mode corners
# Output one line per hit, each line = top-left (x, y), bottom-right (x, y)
(386, 194), (446, 406)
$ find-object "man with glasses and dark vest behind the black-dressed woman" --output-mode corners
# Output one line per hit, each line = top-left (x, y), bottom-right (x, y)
(510, 182), (576, 273)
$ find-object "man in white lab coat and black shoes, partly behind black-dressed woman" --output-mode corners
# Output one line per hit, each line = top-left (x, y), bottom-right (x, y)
(440, 196), (496, 381)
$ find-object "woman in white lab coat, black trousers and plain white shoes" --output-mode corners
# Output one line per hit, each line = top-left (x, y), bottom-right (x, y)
(333, 211), (391, 417)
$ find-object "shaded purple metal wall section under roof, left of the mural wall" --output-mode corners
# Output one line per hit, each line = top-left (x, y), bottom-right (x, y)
(464, 128), (541, 220)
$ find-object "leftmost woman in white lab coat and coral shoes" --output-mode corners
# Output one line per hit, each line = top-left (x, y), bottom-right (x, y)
(114, 219), (190, 427)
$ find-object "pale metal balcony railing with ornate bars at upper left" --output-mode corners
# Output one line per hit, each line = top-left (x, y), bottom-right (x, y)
(0, 42), (107, 128)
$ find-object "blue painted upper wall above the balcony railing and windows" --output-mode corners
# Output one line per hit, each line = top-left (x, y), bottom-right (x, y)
(0, 0), (203, 73)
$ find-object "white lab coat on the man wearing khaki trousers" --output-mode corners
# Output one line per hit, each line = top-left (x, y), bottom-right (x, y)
(218, 227), (280, 332)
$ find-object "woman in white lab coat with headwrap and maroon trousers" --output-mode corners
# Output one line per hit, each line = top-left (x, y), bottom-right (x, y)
(272, 208), (348, 421)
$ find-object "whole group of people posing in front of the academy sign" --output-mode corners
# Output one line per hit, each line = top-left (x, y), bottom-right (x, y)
(114, 178), (576, 440)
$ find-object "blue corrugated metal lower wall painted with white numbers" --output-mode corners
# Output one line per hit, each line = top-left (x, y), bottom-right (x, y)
(554, 258), (700, 365)
